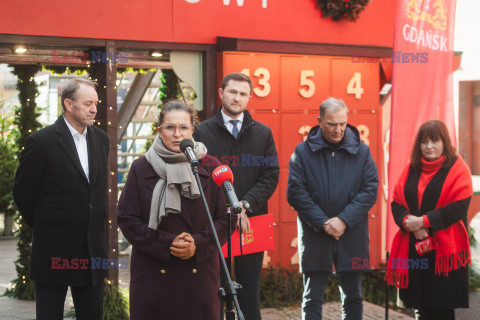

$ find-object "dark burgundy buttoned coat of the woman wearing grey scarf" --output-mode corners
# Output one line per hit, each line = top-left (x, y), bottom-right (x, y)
(117, 156), (232, 320)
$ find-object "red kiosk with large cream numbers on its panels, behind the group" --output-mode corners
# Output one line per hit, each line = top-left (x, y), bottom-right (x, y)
(0, 0), (395, 268)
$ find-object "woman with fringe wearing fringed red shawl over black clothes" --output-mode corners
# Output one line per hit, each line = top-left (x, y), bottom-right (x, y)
(386, 120), (473, 320)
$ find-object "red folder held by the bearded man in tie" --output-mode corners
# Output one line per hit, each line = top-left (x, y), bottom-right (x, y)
(222, 213), (275, 258)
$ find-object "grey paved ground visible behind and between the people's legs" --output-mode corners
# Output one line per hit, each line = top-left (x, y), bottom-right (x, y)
(0, 232), (480, 320)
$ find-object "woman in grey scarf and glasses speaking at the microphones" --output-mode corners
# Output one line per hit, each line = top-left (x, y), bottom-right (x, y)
(117, 101), (236, 320)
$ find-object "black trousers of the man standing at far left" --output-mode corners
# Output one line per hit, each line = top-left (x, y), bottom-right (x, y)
(35, 281), (104, 320)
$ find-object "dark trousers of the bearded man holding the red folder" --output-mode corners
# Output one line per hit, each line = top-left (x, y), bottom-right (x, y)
(220, 252), (263, 320)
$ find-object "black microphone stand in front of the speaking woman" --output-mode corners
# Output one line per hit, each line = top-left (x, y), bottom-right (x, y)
(191, 162), (245, 320)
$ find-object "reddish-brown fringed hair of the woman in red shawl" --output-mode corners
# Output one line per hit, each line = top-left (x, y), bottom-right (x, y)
(410, 120), (457, 170)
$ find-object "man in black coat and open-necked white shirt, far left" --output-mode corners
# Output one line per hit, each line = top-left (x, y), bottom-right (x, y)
(13, 78), (109, 320)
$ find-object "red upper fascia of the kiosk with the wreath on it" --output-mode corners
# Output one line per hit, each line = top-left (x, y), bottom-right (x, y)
(0, 0), (395, 47)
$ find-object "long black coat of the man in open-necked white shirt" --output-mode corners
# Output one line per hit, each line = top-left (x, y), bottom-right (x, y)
(13, 116), (109, 286)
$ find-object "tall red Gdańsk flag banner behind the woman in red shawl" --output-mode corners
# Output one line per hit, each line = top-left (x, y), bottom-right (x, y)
(386, 0), (456, 250)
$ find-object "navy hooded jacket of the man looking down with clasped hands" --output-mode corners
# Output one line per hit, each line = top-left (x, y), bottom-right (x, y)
(287, 125), (378, 273)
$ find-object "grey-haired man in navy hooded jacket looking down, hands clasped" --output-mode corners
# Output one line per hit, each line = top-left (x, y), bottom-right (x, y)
(287, 98), (378, 320)
